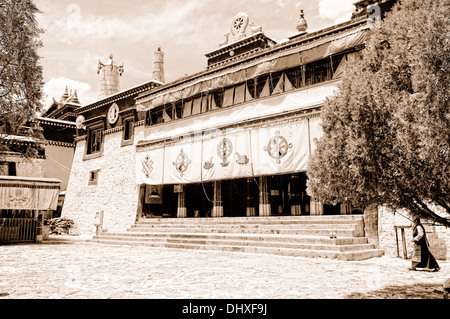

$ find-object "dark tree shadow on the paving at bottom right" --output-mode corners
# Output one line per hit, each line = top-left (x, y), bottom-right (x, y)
(345, 284), (444, 299)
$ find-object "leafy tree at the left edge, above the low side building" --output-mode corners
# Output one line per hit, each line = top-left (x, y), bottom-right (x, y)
(0, 0), (43, 155)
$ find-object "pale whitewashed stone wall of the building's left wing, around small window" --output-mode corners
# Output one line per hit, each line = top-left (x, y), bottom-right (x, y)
(62, 126), (144, 235)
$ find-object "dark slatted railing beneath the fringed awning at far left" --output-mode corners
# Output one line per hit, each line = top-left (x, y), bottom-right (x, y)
(0, 218), (37, 244)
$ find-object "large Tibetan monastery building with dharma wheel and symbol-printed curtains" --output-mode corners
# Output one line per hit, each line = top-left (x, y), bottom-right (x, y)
(62, 1), (400, 238)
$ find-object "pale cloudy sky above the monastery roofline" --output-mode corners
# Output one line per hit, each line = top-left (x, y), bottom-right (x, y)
(34, 0), (356, 108)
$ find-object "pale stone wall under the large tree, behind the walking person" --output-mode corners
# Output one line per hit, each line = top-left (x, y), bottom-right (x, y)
(378, 206), (450, 260)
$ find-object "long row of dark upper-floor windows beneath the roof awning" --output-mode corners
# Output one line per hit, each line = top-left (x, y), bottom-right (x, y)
(145, 55), (343, 126)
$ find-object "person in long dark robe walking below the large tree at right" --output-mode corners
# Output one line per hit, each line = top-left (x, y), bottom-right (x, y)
(410, 217), (440, 271)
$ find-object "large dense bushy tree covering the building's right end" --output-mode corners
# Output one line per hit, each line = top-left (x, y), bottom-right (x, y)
(308, 0), (450, 227)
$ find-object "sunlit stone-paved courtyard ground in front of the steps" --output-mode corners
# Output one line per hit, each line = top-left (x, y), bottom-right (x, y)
(0, 237), (450, 299)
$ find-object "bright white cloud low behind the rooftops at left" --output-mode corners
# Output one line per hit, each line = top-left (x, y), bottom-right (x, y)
(44, 78), (97, 109)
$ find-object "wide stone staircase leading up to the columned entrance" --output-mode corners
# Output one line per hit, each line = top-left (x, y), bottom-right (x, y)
(92, 215), (384, 260)
